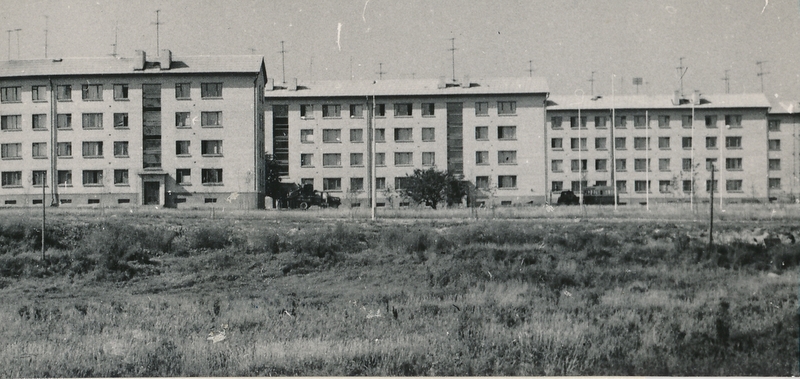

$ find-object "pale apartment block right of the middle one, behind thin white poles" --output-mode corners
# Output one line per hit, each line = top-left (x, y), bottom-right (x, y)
(545, 92), (772, 204)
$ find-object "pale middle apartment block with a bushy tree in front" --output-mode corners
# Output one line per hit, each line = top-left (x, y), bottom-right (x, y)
(265, 78), (548, 206)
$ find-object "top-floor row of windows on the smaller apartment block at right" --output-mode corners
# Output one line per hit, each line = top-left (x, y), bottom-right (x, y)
(550, 114), (742, 129)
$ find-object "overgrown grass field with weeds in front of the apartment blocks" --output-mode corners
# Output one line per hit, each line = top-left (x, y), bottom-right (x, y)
(0, 205), (800, 377)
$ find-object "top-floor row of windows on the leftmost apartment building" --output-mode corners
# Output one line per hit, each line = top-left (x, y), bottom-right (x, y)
(0, 83), (222, 103)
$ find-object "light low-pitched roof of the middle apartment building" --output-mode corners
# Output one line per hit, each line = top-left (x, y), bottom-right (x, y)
(264, 77), (549, 98)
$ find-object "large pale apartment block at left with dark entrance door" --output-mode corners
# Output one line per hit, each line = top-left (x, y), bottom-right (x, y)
(0, 50), (266, 208)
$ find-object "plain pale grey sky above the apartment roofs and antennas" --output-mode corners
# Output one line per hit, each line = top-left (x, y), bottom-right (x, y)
(0, 0), (800, 101)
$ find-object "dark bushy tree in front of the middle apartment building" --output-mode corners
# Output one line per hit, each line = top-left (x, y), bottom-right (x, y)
(401, 167), (467, 209)
